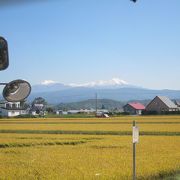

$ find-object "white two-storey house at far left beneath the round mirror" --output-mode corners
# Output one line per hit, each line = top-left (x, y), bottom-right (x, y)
(0, 101), (28, 117)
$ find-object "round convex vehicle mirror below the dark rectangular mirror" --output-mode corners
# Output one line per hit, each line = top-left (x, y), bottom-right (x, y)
(3, 79), (31, 102)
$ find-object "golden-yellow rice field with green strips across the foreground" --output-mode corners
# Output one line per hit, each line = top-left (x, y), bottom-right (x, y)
(0, 116), (180, 180)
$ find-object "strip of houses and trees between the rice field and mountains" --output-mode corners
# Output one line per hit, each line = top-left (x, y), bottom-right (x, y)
(0, 96), (180, 118)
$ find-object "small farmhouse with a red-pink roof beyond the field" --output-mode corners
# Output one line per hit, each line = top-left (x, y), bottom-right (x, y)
(123, 102), (145, 115)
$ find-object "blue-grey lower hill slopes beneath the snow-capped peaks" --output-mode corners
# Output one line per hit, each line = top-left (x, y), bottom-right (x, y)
(28, 87), (180, 104)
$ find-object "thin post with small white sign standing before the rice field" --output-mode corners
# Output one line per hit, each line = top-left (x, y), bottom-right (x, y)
(132, 121), (139, 180)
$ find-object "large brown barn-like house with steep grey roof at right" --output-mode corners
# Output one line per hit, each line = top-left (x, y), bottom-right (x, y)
(146, 96), (179, 113)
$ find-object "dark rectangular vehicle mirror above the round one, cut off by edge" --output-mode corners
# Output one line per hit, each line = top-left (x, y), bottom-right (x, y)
(0, 37), (9, 71)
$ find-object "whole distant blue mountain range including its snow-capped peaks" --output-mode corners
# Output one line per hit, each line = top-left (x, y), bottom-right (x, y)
(28, 78), (180, 104)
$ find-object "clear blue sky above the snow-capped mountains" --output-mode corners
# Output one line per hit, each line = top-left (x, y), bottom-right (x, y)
(0, 0), (180, 89)
